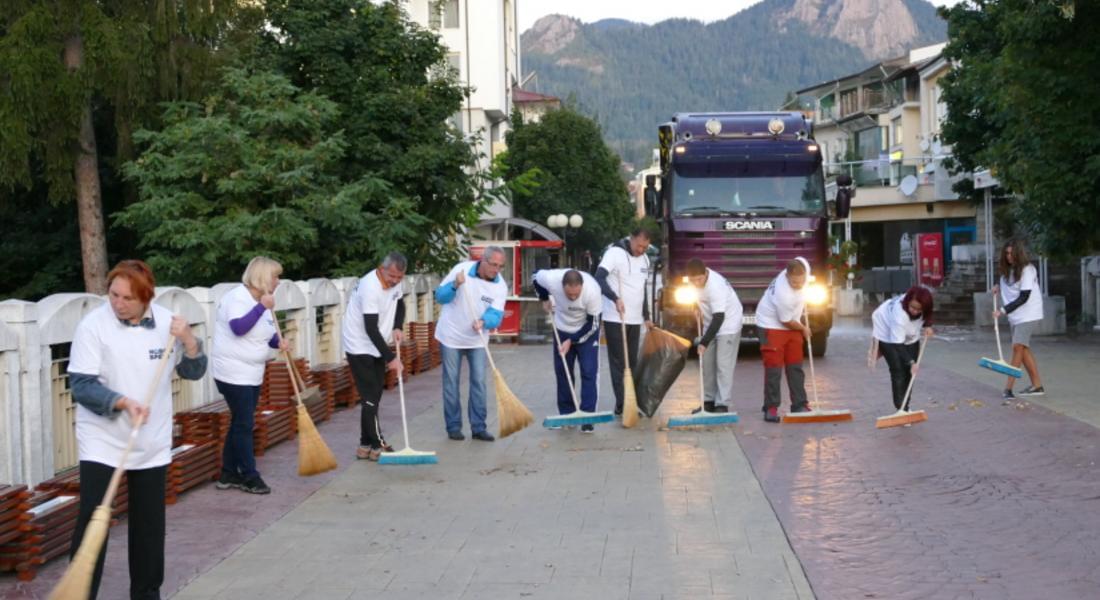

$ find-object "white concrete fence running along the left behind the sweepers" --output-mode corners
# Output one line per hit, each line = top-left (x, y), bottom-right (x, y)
(0, 274), (440, 486)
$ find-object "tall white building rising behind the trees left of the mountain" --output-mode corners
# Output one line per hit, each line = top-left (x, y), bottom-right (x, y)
(405, 0), (520, 218)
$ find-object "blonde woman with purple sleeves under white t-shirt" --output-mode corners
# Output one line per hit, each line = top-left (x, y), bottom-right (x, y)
(210, 257), (287, 494)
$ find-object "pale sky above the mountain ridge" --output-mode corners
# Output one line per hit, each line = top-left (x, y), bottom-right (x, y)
(516, 0), (959, 32)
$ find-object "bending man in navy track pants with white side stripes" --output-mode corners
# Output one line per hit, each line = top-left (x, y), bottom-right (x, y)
(535, 269), (604, 433)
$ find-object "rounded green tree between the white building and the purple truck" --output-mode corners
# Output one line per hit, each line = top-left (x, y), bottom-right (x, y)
(507, 107), (635, 259)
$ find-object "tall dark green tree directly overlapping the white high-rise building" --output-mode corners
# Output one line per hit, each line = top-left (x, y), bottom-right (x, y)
(261, 0), (497, 270)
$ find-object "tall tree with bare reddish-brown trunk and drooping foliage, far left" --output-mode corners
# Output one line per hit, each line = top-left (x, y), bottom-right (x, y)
(0, 0), (254, 293)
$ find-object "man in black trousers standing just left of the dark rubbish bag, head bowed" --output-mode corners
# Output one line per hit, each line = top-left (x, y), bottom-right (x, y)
(596, 227), (653, 415)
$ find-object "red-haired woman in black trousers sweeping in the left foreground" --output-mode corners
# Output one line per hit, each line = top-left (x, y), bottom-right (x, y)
(62, 260), (207, 600)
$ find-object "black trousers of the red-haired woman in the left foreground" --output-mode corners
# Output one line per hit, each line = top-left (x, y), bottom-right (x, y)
(69, 460), (168, 600)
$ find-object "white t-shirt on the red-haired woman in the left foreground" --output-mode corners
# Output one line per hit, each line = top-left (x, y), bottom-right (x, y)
(68, 303), (183, 470)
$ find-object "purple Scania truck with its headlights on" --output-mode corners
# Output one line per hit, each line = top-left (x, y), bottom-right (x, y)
(646, 112), (851, 356)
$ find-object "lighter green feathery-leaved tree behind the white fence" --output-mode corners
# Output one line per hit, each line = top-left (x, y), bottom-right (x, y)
(118, 68), (426, 285)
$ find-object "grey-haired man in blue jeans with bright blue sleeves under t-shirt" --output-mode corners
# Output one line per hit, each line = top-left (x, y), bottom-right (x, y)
(436, 246), (508, 441)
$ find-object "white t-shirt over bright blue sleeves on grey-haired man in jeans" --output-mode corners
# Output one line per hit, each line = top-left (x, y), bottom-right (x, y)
(436, 261), (508, 348)
